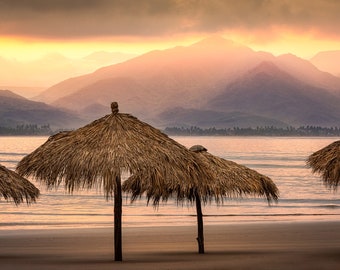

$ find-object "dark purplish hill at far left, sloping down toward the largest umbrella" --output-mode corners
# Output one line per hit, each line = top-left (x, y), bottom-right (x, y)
(0, 90), (85, 129)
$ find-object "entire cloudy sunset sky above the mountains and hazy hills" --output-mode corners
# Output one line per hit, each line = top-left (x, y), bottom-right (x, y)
(0, 0), (340, 60)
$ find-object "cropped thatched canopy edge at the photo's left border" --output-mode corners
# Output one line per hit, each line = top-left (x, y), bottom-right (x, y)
(0, 165), (39, 205)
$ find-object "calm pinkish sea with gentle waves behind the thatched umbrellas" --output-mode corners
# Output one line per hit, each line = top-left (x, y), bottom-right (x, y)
(0, 137), (340, 230)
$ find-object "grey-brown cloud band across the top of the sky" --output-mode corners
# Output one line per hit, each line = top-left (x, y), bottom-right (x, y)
(0, 0), (340, 39)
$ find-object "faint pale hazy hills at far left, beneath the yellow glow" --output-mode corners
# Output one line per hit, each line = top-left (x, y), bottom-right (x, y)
(0, 51), (136, 88)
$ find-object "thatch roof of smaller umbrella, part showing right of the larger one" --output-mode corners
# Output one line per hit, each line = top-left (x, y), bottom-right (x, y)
(190, 145), (279, 201)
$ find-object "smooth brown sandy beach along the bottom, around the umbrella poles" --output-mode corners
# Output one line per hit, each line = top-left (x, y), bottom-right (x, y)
(0, 221), (340, 270)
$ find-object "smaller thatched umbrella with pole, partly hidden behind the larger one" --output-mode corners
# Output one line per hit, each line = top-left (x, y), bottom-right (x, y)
(123, 145), (278, 253)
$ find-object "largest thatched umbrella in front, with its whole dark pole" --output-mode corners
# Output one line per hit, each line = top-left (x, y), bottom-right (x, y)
(17, 102), (214, 261)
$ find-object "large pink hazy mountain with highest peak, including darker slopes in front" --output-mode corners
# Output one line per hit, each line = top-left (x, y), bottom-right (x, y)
(0, 36), (340, 128)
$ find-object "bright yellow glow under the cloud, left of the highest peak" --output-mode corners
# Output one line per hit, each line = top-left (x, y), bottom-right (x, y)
(0, 36), (199, 61)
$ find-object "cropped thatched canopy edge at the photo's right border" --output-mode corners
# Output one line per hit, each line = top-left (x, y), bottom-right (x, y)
(306, 141), (340, 190)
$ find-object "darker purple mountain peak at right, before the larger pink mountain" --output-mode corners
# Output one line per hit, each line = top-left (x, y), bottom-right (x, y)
(208, 62), (340, 126)
